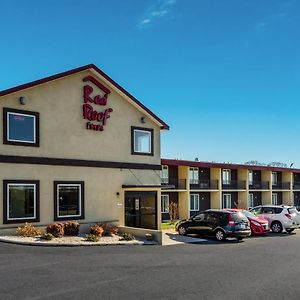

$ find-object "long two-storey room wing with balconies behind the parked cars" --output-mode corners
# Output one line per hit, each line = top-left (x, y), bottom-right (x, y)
(161, 159), (300, 221)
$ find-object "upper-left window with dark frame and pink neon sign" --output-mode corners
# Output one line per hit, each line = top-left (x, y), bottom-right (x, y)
(3, 108), (39, 147)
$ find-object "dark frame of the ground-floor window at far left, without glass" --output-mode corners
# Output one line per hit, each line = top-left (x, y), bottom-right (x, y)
(3, 180), (40, 224)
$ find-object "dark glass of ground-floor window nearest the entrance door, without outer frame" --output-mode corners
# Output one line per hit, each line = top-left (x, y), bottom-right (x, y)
(57, 184), (81, 217)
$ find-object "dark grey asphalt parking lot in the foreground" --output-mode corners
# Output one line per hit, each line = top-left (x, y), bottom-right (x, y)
(0, 231), (300, 299)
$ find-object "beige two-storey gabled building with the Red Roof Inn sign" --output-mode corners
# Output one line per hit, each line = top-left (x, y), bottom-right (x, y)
(0, 65), (169, 236)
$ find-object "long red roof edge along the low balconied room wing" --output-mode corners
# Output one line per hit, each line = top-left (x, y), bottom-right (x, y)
(161, 159), (300, 173)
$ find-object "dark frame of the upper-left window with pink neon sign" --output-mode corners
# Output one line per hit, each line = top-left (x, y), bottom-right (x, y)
(3, 107), (40, 147)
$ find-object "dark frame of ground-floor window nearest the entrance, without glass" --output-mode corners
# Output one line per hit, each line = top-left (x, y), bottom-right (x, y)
(54, 181), (85, 221)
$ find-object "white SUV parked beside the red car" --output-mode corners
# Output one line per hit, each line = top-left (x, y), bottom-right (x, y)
(250, 205), (300, 233)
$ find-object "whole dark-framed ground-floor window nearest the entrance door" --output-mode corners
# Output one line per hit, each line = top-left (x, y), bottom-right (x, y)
(54, 181), (84, 220)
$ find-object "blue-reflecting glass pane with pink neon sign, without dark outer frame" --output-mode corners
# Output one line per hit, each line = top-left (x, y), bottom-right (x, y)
(7, 112), (36, 143)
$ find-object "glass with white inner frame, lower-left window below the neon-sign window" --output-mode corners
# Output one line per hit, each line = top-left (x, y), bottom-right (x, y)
(7, 184), (35, 220)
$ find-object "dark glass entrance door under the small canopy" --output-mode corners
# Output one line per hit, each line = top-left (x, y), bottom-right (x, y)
(125, 192), (157, 229)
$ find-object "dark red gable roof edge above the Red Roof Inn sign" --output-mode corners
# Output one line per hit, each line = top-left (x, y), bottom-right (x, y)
(0, 64), (169, 130)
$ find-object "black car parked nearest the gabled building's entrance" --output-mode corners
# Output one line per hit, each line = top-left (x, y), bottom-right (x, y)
(175, 209), (251, 241)
